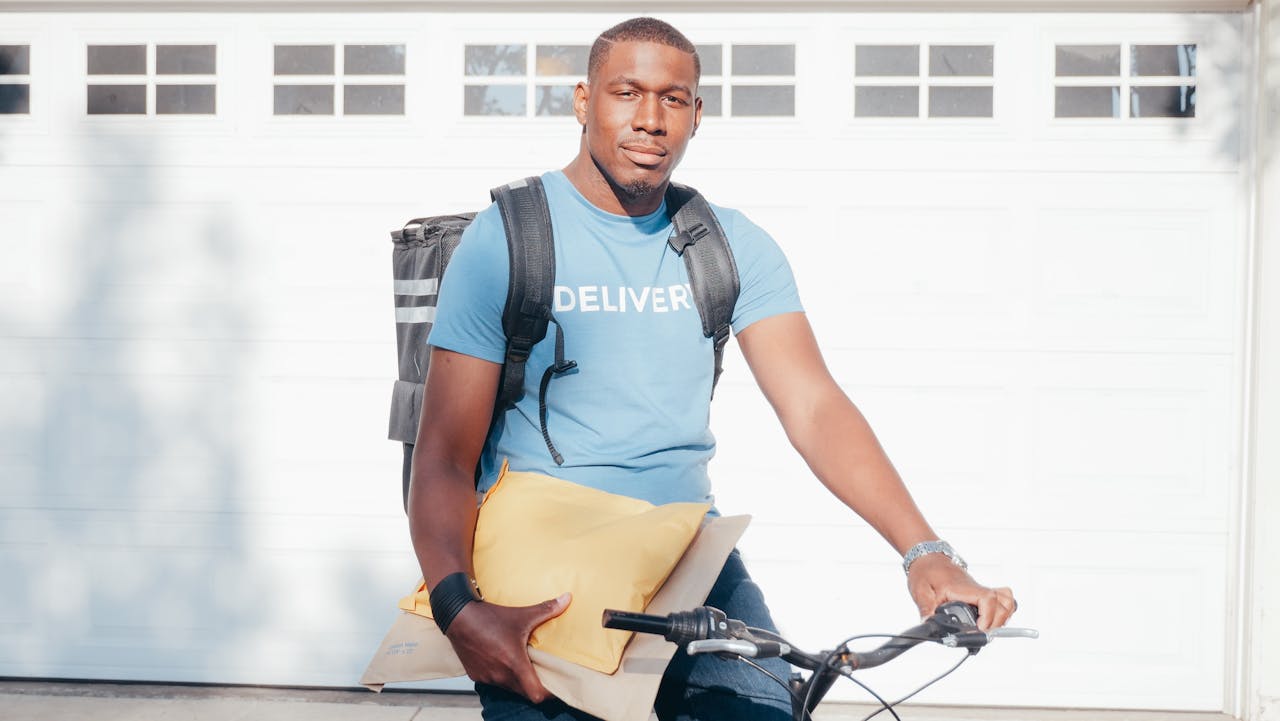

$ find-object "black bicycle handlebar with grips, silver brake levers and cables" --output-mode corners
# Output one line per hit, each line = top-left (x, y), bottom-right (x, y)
(602, 602), (1039, 721)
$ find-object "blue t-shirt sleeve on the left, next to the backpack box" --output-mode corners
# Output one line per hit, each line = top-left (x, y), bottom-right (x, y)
(426, 205), (511, 362)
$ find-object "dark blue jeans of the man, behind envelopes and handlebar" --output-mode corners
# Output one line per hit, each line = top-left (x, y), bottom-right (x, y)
(476, 549), (791, 721)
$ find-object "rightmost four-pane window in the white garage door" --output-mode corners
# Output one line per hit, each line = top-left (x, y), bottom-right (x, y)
(1053, 44), (1196, 119)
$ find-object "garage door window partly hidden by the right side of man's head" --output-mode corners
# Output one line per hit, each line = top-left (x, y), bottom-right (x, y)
(698, 44), (796, 118)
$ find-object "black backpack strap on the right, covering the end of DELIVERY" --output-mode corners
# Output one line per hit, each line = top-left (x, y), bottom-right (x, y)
(667, 183), (740, 396)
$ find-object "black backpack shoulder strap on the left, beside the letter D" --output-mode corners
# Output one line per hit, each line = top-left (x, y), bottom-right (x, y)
(489, 177), (556, 412)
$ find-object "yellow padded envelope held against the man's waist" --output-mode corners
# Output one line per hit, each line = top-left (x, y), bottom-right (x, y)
(401, 467), (710, 674)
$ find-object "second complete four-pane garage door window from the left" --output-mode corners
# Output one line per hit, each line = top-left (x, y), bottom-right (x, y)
(273, 45), (404, 115)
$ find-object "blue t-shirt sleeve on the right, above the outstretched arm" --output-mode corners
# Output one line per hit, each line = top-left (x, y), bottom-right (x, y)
(716, 207), (804, 333)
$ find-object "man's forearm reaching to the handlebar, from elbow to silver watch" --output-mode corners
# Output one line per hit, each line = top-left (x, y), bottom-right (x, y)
(783, 384), (937, 553)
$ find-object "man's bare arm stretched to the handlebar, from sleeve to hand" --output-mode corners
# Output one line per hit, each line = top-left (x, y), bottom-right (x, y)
(737, 312), (1016, 629)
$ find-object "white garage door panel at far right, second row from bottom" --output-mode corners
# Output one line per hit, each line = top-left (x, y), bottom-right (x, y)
(1024, 356), (1239, 531)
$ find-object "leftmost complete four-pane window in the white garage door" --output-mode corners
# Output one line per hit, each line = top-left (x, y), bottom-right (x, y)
(86, 44), (218, 115)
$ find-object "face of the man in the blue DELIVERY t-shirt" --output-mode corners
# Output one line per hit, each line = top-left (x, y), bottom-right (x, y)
(573, 42), (703, 198)
